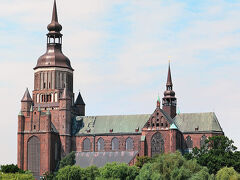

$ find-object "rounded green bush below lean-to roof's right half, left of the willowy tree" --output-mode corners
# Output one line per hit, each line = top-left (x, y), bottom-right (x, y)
(99, 162), (138, 180)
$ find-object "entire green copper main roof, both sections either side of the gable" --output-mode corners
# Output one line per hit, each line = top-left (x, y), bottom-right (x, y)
(72, 112), (222, 138)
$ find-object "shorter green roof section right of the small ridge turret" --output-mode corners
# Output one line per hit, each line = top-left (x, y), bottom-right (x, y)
(174, 112), (223, 133)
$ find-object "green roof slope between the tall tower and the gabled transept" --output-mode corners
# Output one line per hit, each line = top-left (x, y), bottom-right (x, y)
(74, 114), (150, 136)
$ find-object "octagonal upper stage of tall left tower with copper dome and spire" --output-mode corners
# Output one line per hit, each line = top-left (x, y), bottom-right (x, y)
(33, 0), (74, 109)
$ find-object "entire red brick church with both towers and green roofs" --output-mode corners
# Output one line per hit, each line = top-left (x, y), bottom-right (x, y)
(17, 2), (224, 177)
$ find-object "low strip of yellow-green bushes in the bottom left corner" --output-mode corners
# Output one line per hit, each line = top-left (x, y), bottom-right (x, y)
(0, 173), (34, 180)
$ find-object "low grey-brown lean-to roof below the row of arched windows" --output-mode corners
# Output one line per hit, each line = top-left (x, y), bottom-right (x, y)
(76, 151), (138, 168)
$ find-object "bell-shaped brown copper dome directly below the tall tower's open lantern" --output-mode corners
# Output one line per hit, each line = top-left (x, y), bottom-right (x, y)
(34, 44), (73, 70)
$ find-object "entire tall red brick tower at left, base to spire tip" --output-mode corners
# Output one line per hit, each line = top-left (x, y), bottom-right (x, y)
(18, 0), (82, 179)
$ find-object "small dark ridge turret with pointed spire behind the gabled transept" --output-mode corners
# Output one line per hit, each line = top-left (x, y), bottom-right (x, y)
(162, 63), (177, 118)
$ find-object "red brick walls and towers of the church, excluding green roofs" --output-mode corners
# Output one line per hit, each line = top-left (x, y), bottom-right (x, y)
(17, 0), (223, 176)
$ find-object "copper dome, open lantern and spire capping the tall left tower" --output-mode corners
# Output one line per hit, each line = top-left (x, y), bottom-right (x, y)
(34, 0), (73, 70)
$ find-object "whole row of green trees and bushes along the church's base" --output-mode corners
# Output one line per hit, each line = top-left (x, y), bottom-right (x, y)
(0, 136), (240, 180)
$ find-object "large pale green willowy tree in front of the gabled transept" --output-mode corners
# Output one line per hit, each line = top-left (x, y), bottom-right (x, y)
(136, 152), (211, 180)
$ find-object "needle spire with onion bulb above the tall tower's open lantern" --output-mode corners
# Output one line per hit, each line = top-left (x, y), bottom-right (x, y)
(47, 0), (62, 33)
